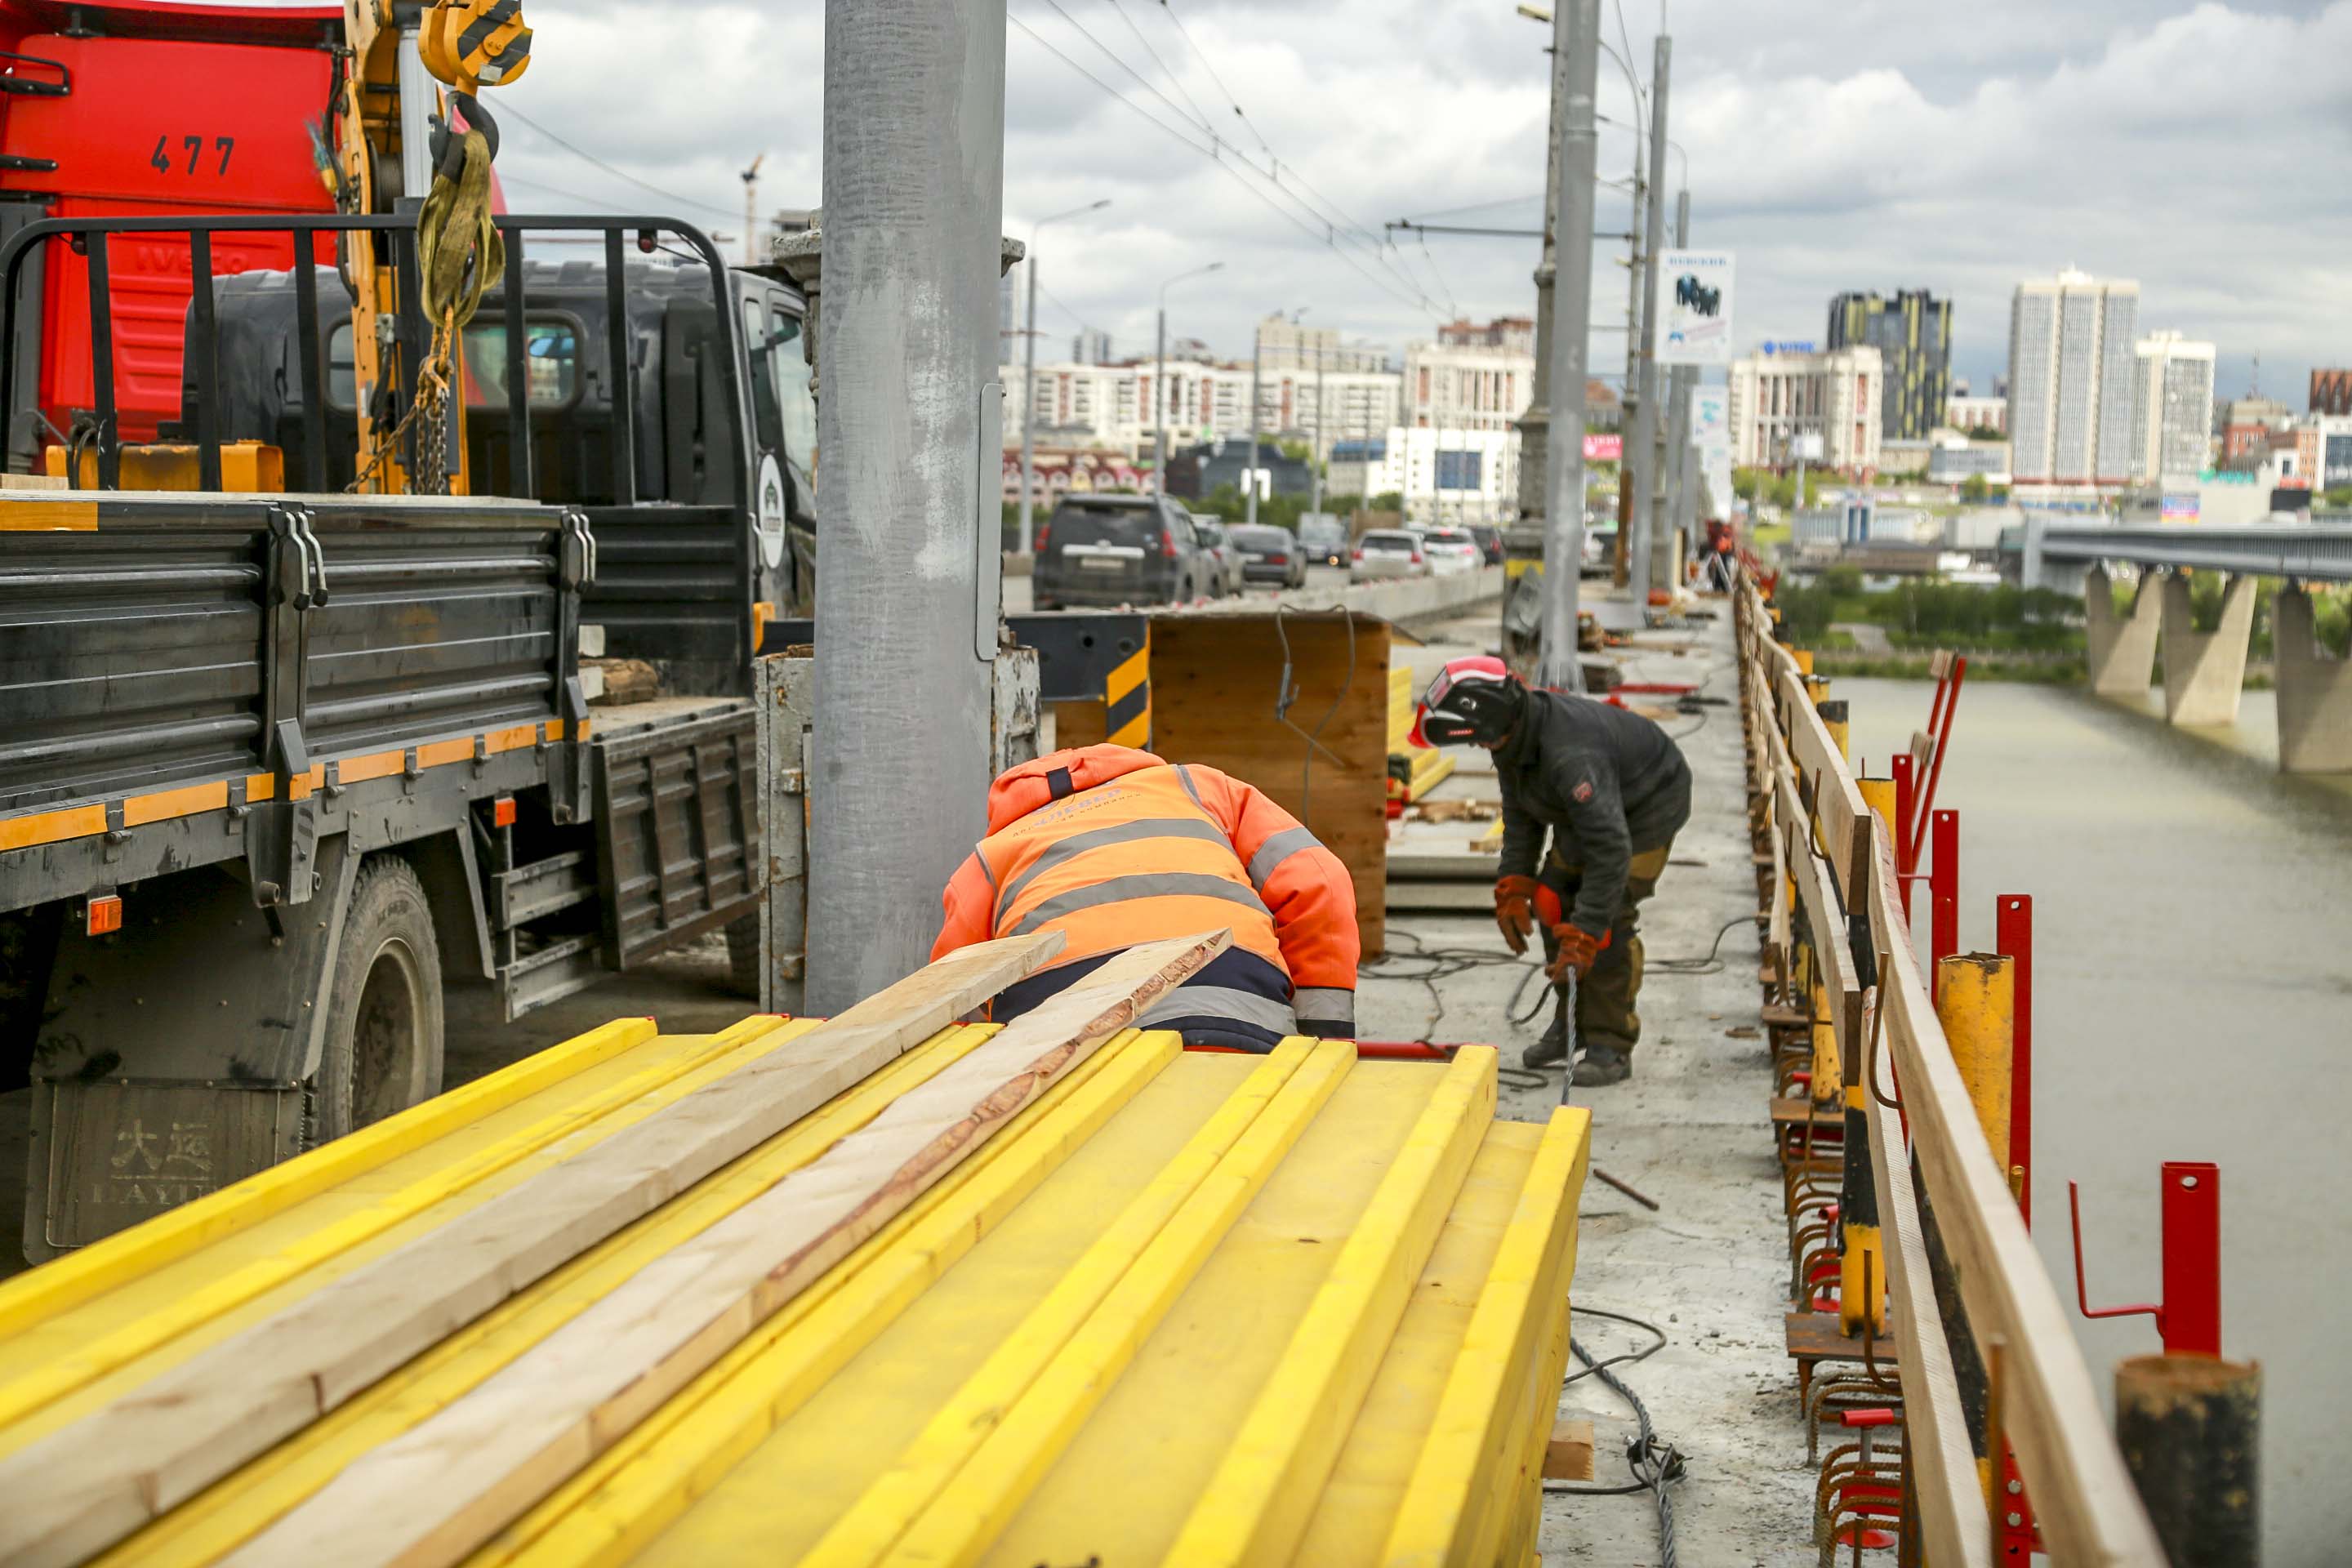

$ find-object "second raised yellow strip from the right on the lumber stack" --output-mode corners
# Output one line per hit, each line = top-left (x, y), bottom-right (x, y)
(1169, 1046), (1496, 1563)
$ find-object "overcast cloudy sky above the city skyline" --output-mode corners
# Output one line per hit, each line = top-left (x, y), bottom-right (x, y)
(499, 0), (2352, 407)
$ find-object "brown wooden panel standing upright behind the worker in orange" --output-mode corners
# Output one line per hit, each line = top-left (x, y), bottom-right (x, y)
(1147, 611), (1388, 959)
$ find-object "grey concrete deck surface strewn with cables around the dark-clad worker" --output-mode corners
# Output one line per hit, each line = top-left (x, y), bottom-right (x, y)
(1357, 599), (1815, 1568)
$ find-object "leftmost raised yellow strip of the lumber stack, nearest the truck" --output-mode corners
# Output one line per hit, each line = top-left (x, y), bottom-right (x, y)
(0, 1018), (663, 1373)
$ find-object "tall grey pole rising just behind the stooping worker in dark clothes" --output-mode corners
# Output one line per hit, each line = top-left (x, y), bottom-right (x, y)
(1521, 0), (1601, 691)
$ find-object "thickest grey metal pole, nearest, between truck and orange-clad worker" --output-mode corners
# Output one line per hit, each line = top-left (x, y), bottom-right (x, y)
(807, 0), (1004, 1013)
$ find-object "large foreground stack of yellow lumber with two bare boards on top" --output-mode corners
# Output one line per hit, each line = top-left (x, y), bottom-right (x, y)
(0, 936), (1588, 1563)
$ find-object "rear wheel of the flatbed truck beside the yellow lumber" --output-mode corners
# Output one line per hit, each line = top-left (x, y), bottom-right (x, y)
(310, 856), (442, 1143)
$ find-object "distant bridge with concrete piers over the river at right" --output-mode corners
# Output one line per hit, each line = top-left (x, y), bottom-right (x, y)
(2002, 517), (2352, 773)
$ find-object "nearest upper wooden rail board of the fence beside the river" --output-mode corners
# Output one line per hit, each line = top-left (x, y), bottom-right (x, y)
(1865, 818), (2166, 1568)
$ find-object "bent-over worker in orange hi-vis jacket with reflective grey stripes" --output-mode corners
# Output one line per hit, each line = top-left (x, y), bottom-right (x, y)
(931, 746), (1360, 1051)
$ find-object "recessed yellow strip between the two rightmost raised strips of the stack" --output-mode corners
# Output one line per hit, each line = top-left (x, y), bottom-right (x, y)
(1291, 1121), (1543, 1568)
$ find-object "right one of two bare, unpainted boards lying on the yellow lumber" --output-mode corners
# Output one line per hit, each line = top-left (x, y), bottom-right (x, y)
(224, 931), (1230, 1568)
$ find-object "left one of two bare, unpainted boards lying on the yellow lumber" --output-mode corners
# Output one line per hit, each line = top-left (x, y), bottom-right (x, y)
(0, 933), (1061, 1563)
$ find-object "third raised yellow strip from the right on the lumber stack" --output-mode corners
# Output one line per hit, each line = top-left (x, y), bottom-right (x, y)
(800, 1039), (1310, 1568)
